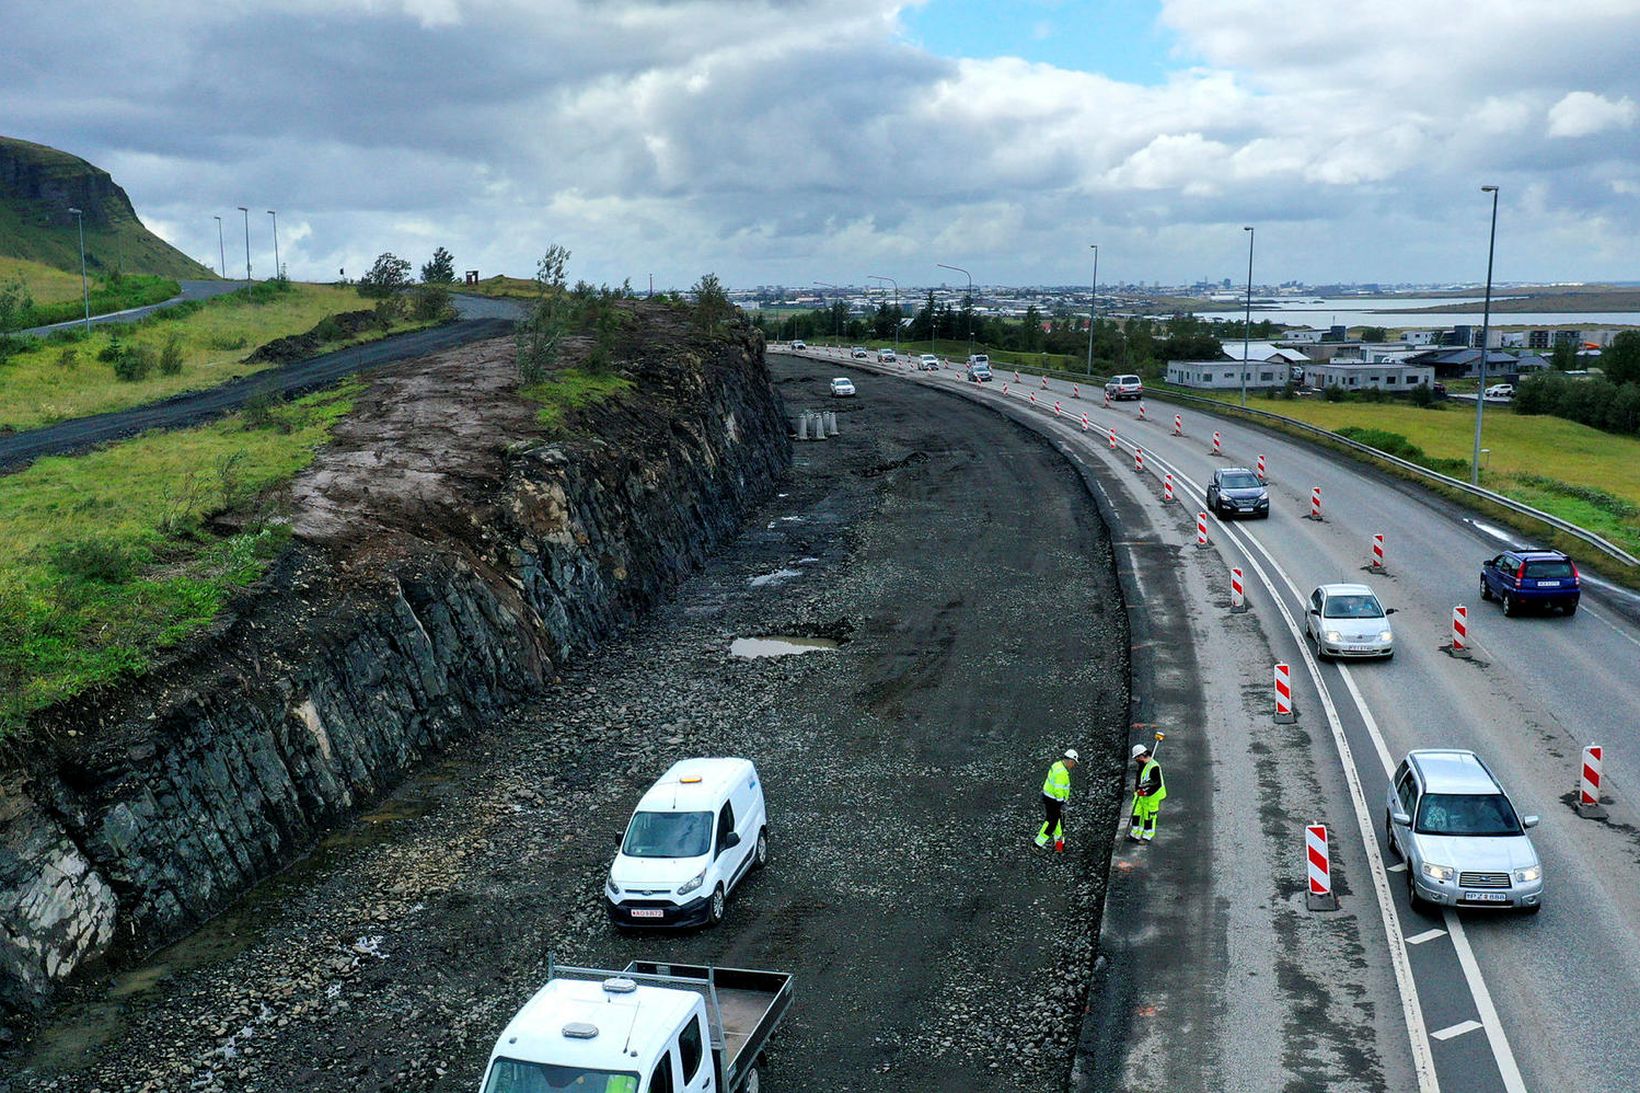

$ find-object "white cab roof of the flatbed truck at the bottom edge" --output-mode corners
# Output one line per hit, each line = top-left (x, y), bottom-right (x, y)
(494, 978), (700, 1075)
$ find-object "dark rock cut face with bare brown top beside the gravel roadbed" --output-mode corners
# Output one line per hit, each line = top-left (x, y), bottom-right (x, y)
(0, 309), (790, 1013)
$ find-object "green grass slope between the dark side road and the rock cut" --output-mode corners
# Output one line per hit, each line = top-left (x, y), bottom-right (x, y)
(0, 381), (362, 735)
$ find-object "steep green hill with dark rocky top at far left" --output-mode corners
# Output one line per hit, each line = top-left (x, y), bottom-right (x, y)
(0, 136), (215, 279)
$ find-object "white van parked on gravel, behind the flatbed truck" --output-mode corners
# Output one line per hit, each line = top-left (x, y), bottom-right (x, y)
(604, 758), (769, 926)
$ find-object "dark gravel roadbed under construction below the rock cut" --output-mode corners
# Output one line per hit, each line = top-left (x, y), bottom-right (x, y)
(0, 352), (1128, 1093)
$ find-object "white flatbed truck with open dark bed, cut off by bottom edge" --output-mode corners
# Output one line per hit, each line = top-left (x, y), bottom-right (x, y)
(479, 960), (792, 1093)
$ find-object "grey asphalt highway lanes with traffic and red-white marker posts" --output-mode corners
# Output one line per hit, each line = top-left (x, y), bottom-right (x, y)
(803, 349), (1640, 1090)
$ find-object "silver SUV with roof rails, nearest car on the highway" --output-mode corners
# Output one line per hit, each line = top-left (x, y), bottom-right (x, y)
(1384, 748), (1543, 914)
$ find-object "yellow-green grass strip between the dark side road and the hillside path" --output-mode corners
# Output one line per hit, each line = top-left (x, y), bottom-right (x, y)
(0, 282), (431, 430)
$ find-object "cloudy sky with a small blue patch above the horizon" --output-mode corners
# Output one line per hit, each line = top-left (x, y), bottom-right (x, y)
(0, 0), (1640, 287)
